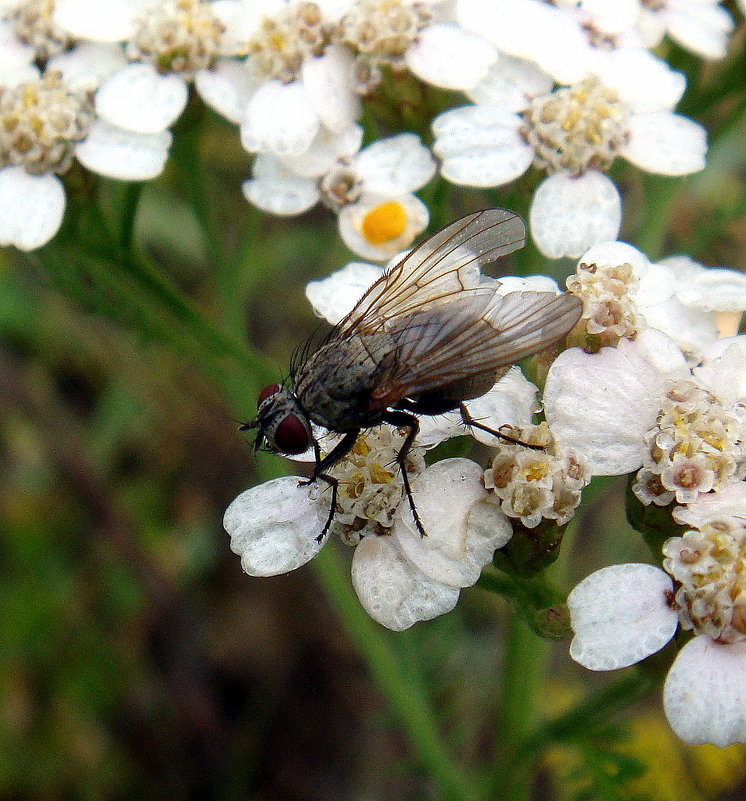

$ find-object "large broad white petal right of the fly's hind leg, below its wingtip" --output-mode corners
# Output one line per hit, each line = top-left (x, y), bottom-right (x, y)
(544, 329), (690, 475)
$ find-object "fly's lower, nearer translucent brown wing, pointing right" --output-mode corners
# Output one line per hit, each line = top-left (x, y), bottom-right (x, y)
(371, 287), (583, 408)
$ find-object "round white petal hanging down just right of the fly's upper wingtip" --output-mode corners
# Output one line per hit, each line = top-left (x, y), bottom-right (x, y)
(529, 170), (622, 259)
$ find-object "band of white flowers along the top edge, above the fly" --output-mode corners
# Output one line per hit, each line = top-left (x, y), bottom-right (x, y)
(0, 0), (733, 253)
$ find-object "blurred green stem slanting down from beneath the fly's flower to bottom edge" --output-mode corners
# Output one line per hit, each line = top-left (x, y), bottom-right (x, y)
(313, 546), (478, 801)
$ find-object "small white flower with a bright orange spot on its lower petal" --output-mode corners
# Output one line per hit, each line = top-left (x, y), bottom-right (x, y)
(243, 125), (436, 261)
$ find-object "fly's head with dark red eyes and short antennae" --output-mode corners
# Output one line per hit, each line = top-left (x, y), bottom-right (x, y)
(241, 384), (313, 456)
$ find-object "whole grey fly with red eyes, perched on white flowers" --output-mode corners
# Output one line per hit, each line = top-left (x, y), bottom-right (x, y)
(242, 209), (582, 541)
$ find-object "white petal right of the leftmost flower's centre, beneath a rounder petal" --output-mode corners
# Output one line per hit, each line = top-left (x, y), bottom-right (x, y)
(75, 120), (171, 181)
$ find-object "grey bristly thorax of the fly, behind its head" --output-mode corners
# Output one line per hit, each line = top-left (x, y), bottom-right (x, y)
(295, 331), (396, 431)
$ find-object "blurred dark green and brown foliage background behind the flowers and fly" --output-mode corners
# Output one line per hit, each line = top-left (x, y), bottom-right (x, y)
(0, 37), (746, 801)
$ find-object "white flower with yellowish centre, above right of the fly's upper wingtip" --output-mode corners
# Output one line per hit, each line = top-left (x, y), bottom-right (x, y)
(433, 70), (706, 258)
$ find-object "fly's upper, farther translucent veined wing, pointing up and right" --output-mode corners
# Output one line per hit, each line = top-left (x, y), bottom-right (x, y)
(330, 209), (526, 341)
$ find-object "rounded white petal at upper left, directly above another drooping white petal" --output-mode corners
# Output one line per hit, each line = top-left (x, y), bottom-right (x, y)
(96, 64), (187, 133)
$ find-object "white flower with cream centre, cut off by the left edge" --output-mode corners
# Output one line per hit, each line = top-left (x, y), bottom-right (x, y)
(0, 62), (170, 250)
